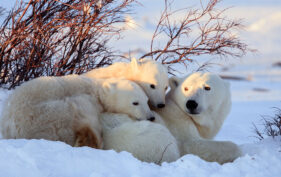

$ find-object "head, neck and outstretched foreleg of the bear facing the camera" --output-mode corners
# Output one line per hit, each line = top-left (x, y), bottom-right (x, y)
(156, 72), (241, 163)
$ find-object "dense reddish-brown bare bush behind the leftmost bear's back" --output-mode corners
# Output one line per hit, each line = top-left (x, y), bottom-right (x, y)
(0, 0), (134, 88)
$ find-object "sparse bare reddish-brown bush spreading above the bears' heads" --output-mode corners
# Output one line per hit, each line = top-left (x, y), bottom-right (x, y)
(140, 0), (250, 73)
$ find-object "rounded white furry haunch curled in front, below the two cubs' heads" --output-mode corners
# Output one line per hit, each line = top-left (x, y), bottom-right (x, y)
(100, 113), (180, 164)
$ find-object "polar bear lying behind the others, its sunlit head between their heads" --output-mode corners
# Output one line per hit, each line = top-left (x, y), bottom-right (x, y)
(84, 59), (169, 108)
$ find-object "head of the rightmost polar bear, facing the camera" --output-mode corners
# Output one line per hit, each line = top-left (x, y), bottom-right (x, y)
(168, 72), (231, 121)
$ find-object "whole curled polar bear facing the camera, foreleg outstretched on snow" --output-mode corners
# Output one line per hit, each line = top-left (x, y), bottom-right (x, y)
(101, 73), (241, 164)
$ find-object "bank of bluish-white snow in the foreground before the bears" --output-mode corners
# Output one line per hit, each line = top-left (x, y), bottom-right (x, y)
(0, 139), (281, 177)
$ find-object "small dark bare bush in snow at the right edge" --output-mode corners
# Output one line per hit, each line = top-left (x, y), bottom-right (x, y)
(254, 108), (281, 140)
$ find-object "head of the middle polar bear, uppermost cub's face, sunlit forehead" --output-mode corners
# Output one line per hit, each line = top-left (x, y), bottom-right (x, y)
(131, 59), (169, 108)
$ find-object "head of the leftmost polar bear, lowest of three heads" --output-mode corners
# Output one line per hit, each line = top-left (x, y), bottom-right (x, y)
(100, 79), (155, 121)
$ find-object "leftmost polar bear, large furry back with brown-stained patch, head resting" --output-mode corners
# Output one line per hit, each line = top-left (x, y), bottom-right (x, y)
(1, 75), (154, 148)
